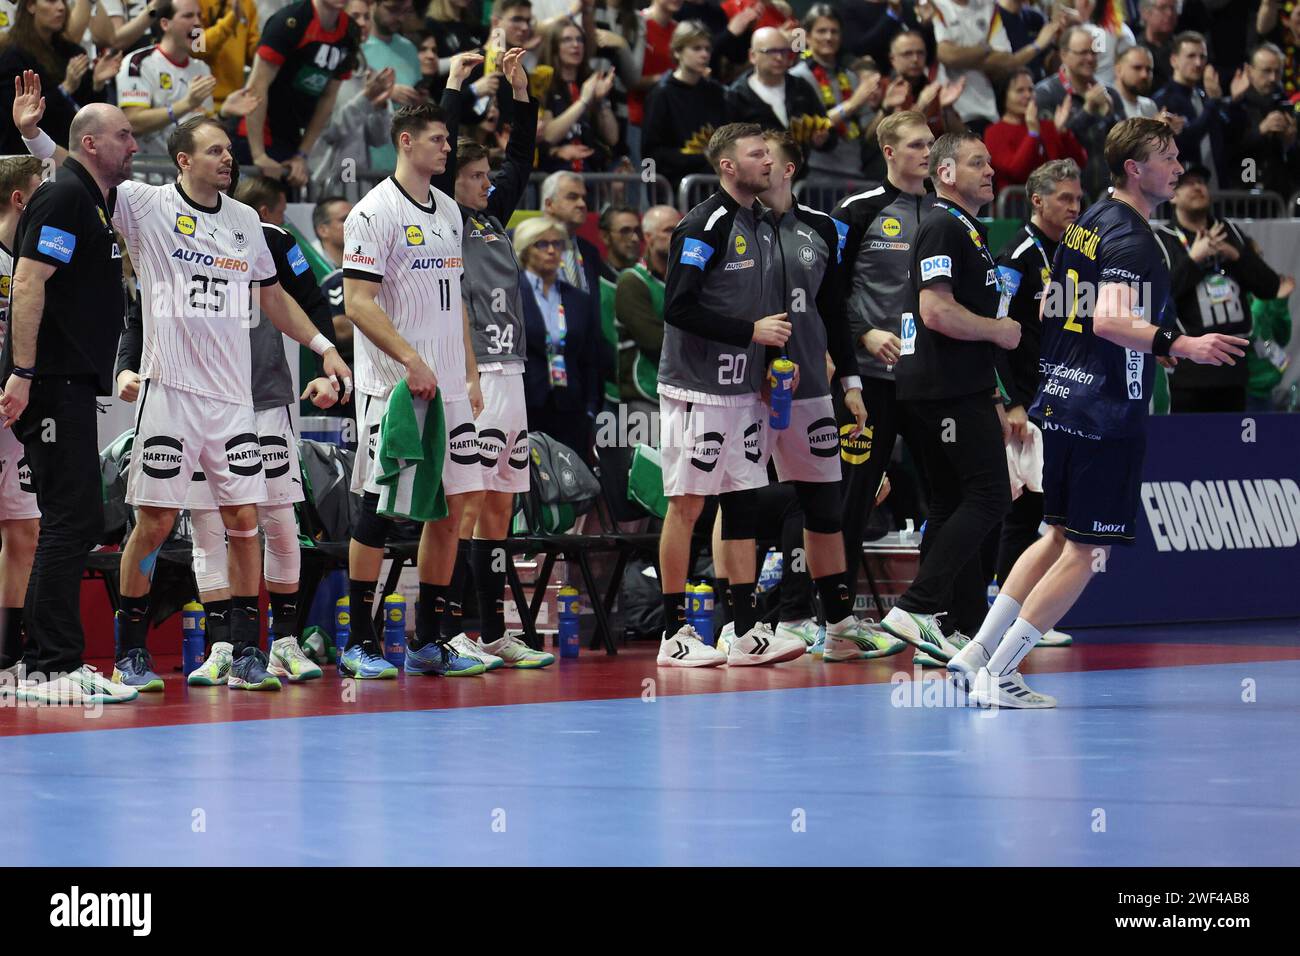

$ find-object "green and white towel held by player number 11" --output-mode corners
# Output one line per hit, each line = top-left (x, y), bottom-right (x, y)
(374, 380), (447, 522)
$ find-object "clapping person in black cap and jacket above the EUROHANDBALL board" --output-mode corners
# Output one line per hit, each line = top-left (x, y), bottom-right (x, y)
(1156, 167), (1295, 412)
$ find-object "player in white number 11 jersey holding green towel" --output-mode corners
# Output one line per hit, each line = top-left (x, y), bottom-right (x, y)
(339, 105), (484, 679)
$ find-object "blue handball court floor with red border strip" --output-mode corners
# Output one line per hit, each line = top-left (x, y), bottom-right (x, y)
(0, 620), (1300, 866)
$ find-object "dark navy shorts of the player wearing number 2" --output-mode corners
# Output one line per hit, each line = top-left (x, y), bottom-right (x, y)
(1043, 428), (1147, 545)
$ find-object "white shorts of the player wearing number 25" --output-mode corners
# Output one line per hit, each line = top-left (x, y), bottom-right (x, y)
(126, 380), (267, 509)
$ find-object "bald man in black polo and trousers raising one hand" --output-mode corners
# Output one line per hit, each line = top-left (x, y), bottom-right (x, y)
(0, 95), (137, 706)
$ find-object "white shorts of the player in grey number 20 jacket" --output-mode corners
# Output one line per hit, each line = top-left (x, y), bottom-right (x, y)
(659, 395), (767, 498)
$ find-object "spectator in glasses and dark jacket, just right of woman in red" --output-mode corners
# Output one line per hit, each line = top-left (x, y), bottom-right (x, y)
(1034, 26), (1121, 195)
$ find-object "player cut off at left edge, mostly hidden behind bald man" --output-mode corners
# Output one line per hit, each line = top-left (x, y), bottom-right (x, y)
(0, 156), (40, 696)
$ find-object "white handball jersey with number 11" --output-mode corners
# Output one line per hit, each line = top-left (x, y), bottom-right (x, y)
(343, 177), (467, 402)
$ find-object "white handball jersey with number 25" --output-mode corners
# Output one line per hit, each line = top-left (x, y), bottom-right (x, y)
(113, 179), (276, 406)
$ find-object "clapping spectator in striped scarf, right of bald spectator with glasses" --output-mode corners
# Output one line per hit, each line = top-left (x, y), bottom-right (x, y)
(790, 4), (884, 177)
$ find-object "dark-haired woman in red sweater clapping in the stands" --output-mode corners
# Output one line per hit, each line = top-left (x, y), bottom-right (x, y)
(984, 68), (1088, 193)
